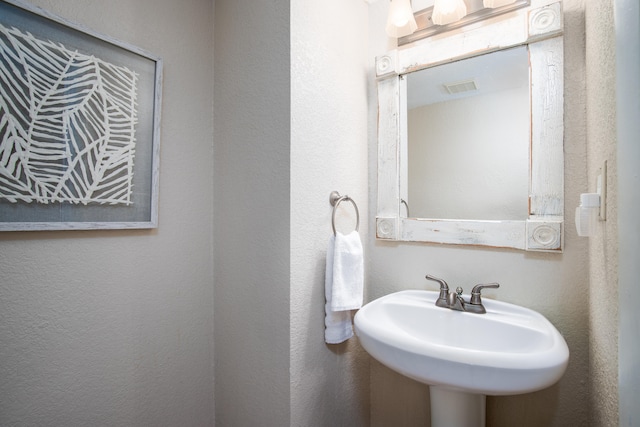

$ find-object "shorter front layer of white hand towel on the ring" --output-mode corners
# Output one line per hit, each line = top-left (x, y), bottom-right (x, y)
(331, 231), (364, 311)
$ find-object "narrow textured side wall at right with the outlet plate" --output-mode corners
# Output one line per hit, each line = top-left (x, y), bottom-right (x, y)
(584, 0), (618, 426)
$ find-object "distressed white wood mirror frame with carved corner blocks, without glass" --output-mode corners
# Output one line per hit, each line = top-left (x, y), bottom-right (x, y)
(376, 0), (564, 252)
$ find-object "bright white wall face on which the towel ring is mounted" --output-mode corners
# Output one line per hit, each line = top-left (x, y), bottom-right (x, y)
(290, 0), (372, 427)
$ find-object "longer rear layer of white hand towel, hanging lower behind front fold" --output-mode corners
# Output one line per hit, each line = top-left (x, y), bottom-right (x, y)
(324, 235), (353, 344)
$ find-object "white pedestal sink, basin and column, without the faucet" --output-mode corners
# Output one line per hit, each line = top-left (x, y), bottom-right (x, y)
(355, 290), (569, 427)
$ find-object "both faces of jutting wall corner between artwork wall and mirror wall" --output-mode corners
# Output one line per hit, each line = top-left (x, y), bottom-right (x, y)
(214, 0), (370, 426)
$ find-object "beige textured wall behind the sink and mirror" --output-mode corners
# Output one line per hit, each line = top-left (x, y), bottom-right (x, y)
(368, 0), (589, 427)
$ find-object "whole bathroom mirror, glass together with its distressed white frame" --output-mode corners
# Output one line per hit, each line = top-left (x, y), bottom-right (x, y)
(376, 0), (564, 252)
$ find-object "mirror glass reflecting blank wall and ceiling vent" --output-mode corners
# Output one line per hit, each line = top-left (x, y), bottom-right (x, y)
(400, 46), (531, 220)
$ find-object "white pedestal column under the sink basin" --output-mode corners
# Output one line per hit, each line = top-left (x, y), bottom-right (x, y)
(429, 386), (486, 427)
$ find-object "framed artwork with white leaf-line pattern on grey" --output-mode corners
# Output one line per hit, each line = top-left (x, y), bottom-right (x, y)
(0, 0), (162, 231)
